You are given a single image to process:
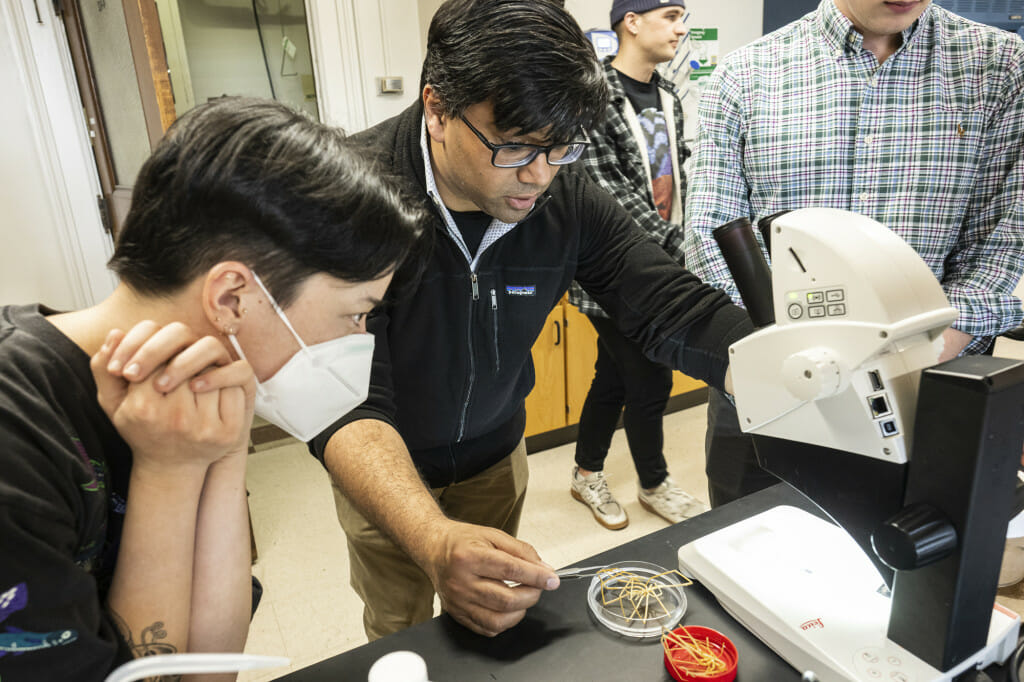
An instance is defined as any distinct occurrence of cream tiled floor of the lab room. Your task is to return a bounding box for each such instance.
[239,341,1024,682]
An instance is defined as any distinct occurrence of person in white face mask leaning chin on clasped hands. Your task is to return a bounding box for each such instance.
[0,98,422,681]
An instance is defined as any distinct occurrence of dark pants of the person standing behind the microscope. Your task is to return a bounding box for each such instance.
[705,388,779,507]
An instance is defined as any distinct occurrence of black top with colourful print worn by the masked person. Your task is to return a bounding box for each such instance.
[0,305,132,682]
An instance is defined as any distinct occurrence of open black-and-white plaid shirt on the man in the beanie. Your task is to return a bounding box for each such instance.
[569,56,690,317]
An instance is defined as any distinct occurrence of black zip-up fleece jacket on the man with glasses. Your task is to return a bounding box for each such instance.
[310,103,754,487]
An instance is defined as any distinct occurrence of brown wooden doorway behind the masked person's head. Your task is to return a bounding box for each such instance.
[59,0,318,236]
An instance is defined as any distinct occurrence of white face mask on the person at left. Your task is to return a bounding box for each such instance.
[227,272,374,442]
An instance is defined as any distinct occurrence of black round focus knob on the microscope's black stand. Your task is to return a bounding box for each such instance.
[871,503,956,570]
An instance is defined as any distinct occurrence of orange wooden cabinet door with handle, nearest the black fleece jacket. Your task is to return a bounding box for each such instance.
[526,302,566,436]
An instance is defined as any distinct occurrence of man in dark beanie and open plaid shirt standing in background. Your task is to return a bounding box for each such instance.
[569,0,706,529]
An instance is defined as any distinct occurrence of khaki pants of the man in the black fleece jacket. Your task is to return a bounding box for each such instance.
[333,440,529,641]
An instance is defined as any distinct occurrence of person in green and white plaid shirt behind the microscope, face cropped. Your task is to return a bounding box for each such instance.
[685,0,1024,506]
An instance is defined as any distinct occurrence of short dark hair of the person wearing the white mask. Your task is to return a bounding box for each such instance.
[110,97,424,305]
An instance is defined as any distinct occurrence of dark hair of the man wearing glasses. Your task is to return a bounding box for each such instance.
[420,0,608,141]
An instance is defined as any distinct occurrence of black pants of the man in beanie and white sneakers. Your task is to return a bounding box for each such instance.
[575,315,672,488]
